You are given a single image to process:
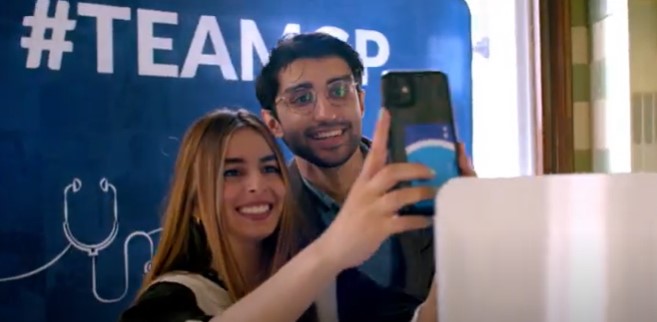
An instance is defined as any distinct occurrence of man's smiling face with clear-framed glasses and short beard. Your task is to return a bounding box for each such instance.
[263,57,364,168]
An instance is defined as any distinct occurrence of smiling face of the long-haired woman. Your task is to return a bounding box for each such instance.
[222,128,286,242]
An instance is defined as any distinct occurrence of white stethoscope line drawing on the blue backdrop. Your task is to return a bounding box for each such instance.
[0,178,162,303]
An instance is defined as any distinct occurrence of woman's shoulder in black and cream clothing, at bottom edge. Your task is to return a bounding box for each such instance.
[120,272,232,322]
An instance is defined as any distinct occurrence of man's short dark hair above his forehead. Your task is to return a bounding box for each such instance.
[256,32,364,112]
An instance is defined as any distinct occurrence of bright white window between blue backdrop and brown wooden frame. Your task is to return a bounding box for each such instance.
[467,0,536,177]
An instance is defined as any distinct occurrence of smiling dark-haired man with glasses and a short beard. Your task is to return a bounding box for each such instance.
[256,33,473,299]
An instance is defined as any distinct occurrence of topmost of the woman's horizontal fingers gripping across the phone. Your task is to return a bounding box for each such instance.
[367,163,435,195]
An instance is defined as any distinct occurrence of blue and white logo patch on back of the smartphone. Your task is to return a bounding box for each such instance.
[405,123,459,212]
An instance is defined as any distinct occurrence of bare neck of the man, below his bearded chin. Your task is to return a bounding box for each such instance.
[296,148,364,204]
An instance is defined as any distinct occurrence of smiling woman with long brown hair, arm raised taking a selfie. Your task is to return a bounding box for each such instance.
[121,110,436,322]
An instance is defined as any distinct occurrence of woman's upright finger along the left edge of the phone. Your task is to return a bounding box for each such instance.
[361,107,390,178]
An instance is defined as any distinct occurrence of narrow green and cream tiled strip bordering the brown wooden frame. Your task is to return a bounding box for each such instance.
[570,0,593,172]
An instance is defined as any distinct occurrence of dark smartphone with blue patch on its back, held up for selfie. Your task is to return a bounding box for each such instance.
[381,70,459,216]
